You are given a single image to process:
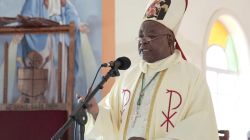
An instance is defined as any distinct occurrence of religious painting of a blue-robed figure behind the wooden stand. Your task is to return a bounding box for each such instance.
[0,0,102,103]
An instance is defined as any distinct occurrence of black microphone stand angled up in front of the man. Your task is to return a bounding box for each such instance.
[51,66,120,140]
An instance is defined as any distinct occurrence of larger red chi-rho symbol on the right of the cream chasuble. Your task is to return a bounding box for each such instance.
[161,89,182,132]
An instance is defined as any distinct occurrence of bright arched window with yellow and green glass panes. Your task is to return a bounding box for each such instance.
[206,15,250,140]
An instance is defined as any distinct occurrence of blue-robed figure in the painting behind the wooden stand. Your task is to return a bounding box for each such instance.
[0,0,100,102]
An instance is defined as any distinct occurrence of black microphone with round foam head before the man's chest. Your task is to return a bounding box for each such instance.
[101,56,131,70]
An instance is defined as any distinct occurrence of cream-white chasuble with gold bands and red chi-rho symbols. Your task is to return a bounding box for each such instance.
[86,50,219,140]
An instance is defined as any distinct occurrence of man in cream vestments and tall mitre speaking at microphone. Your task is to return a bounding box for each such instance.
[83,0,219,140]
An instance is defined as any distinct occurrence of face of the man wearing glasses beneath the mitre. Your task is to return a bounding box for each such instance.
[138,20,175,63]
